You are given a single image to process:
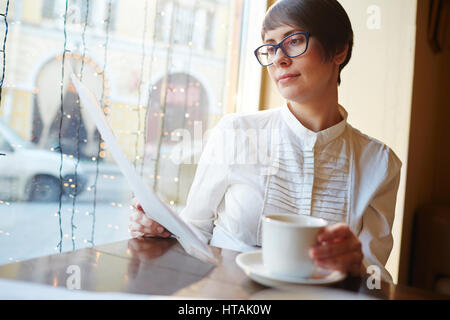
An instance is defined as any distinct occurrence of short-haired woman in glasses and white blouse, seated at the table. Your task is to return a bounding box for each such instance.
[130,0,401,281]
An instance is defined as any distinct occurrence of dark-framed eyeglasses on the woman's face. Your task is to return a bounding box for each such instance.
[255,32,310,67]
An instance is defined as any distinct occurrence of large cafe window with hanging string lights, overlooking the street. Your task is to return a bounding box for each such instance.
[0,0,266,264]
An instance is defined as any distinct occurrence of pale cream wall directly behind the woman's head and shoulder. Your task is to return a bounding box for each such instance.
[261,0,416,281]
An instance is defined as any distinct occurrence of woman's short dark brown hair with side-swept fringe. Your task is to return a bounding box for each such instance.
[261,0,353,84]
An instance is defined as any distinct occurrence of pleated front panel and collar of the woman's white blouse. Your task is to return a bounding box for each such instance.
[264,106,351,222]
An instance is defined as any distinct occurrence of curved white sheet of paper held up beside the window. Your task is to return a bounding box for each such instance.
[71,72,217,264]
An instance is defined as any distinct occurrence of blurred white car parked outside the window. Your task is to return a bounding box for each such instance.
[0,121,87,202]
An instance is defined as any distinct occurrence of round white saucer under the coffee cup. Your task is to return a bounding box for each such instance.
[236,250,346,287]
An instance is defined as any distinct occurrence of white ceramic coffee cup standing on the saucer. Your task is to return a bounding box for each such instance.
[262,214,327,278]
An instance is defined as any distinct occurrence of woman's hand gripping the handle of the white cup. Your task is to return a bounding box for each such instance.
[309,223,363,276]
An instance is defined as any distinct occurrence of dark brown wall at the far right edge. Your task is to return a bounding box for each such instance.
[399,1,450,284]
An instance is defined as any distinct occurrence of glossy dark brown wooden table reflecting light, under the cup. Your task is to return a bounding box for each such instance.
[0,238,450,300]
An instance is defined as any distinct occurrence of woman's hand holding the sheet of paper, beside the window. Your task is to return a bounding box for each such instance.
[128,198,171,238]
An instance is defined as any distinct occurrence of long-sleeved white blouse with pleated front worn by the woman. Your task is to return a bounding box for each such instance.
[180,104,401,281]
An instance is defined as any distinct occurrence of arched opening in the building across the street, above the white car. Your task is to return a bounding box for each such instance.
[32,54,107,159]
